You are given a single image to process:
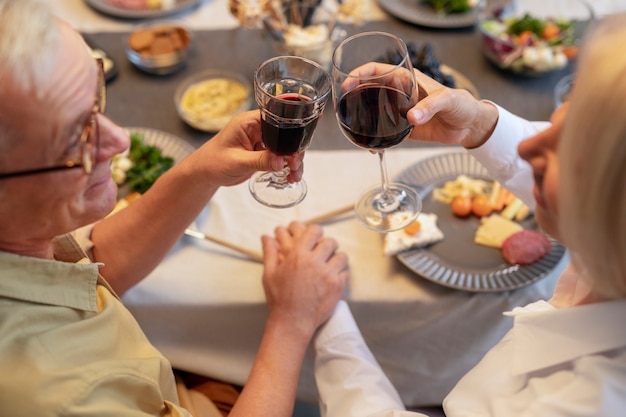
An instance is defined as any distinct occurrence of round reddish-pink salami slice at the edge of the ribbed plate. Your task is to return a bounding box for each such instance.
[502,229,552,265]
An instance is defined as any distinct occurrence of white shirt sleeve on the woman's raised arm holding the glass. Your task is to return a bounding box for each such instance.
[468,103,550,208]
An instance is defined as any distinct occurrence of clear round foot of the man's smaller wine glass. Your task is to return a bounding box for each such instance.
[248,172,307,208]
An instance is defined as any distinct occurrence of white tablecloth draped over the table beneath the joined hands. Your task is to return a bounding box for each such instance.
[124,148,563,405]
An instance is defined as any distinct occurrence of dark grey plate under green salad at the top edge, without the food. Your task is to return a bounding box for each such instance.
[378,0,476,29]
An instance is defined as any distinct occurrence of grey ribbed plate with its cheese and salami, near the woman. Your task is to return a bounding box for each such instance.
[385,151,565,292]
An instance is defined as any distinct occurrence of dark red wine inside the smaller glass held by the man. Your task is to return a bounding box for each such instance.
[261,93,318,155]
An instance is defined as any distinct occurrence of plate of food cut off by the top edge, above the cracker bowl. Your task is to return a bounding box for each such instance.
[84,0,200,19]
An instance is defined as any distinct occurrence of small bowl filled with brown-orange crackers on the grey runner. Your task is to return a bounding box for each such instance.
[126,22,191,75]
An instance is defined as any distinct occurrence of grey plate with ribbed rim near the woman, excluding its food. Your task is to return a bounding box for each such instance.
[396,151,565,292]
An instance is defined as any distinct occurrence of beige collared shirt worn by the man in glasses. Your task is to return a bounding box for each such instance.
[0,235,190,417]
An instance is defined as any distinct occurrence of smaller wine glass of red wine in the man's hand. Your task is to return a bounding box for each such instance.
[248,56,331,208]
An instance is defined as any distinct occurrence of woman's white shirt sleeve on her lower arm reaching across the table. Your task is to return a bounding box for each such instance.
[313,300,422,417]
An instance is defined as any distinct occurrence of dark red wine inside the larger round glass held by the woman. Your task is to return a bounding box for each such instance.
[337,84,413,149]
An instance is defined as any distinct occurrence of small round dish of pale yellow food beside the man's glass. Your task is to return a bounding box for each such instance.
[174,70,252,132]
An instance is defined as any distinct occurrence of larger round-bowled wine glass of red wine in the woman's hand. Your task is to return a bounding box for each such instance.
[332,32,422,232]
